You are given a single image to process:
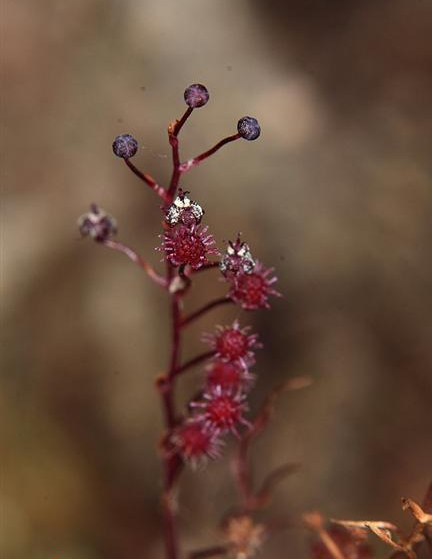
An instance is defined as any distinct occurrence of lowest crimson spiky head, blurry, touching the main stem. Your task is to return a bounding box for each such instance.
[170,419,222,467]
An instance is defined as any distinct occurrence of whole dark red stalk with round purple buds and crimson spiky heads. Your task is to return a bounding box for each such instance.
[78,84,286,559]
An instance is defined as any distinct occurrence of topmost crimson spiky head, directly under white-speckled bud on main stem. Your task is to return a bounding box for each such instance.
[157,224,219,270]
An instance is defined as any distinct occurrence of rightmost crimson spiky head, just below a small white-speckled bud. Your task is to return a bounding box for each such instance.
[229,262,280,310]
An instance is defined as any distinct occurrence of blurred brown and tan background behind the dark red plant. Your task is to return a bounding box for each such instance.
[0,0,432,559]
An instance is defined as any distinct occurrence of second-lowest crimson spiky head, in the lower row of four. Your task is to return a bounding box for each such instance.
[190,386,250,437]
